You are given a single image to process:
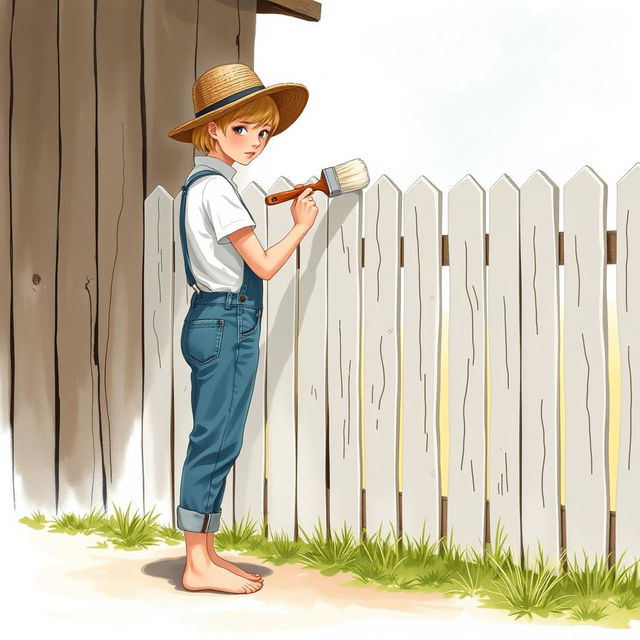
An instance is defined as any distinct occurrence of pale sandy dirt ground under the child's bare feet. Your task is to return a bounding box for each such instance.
[0,522,638,640]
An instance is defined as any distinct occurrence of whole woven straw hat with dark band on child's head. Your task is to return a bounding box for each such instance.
[168,64,309,142]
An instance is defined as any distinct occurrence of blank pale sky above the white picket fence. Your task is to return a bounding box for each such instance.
[238,0,640,231]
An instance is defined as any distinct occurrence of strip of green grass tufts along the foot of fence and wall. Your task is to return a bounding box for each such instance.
[20,505,640,628]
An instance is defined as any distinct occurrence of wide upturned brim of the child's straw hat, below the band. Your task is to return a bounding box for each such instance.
[168,82,309,142]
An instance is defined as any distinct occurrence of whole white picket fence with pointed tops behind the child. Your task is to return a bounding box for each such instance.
[143,164,640,562]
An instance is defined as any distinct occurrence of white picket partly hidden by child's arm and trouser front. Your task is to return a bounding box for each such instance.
[232,182,267,526]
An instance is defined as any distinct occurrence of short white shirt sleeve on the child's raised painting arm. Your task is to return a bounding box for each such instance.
[202,176,256,244]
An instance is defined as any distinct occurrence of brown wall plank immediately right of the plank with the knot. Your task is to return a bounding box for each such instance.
[57,0,104,512]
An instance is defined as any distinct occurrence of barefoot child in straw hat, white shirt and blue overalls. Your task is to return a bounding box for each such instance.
[169,64,318,593]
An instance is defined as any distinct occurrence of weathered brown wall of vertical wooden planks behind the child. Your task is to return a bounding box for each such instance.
[0,0,256,514]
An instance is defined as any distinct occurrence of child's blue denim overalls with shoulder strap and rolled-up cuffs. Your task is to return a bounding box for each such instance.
[176,169,263,533]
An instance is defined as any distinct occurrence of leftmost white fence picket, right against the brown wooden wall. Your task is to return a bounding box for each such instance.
[142,187,173,522]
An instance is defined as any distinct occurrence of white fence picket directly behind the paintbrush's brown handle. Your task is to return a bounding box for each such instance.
[263,178,298,538]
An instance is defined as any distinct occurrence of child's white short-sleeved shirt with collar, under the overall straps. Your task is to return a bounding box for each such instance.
[184,156,256,292]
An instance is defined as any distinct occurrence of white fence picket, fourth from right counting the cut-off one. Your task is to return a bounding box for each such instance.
[487,175,522,562]
